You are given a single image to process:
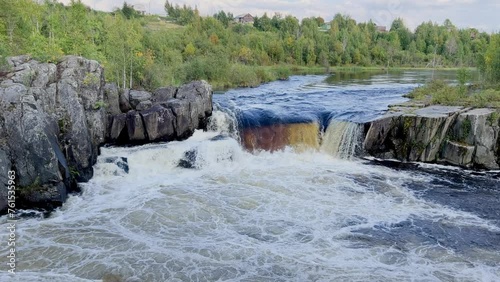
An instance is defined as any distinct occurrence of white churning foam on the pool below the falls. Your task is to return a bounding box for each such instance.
[0,122,500,281]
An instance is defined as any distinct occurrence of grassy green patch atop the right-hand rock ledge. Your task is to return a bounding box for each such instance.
[405,80,500,109]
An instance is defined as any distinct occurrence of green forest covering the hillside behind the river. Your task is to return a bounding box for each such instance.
[0,0,500,89]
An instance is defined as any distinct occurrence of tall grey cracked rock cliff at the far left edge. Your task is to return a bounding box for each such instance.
[0,56,106,210]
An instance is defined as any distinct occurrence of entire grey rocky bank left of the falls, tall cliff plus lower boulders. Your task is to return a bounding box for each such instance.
[0,56,212,214]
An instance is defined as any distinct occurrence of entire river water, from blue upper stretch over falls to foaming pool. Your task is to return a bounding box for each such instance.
[0,73,500,282]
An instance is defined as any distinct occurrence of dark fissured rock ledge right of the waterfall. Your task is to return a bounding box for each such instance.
[364,106,500,169]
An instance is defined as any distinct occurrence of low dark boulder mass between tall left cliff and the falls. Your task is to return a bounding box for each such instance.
[107,81,213,144]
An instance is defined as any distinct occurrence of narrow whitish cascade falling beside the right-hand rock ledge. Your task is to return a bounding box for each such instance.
[320,120,363,159]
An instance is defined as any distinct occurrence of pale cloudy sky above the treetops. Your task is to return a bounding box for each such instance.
[60,0,500,32]
